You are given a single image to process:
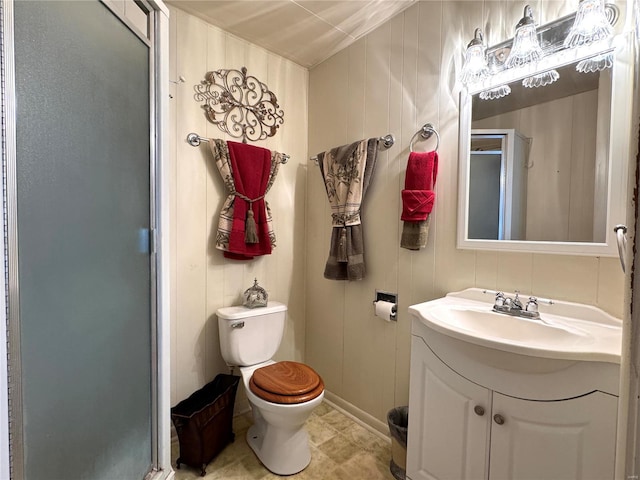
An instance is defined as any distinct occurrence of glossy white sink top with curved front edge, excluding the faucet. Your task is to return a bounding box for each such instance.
[409,288,622,364]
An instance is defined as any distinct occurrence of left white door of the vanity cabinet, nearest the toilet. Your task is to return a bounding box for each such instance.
[407,336,491,480]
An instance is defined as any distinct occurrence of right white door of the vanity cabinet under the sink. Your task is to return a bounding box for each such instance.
[489,392,618,480]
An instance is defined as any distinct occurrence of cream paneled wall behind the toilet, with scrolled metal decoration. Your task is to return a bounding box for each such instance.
[169,7,308,405]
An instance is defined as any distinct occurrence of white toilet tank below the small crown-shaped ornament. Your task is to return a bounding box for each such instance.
[216,302,287,367]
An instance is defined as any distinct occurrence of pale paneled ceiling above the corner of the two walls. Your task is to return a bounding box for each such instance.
[167,0,414,68]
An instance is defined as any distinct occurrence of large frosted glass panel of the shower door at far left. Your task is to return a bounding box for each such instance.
[15,1,152,480]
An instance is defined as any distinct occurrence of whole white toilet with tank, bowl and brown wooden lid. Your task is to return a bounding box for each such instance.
[216,301,324,475]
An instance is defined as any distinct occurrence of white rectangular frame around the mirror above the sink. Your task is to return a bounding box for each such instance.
[457,32,634,257]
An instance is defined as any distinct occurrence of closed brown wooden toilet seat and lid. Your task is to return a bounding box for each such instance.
[249,361,324,404]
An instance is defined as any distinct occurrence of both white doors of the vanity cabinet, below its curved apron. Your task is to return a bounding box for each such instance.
[407,334,618,480]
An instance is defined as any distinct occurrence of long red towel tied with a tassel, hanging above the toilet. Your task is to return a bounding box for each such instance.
[224,142,271,260]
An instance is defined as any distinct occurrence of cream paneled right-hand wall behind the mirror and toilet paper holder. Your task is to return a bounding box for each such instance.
[305,0,624,429]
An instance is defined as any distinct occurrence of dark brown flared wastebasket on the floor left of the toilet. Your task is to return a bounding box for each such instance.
[171,374,240,477]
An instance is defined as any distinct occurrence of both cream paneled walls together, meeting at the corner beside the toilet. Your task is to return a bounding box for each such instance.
[170,0,624,436]
